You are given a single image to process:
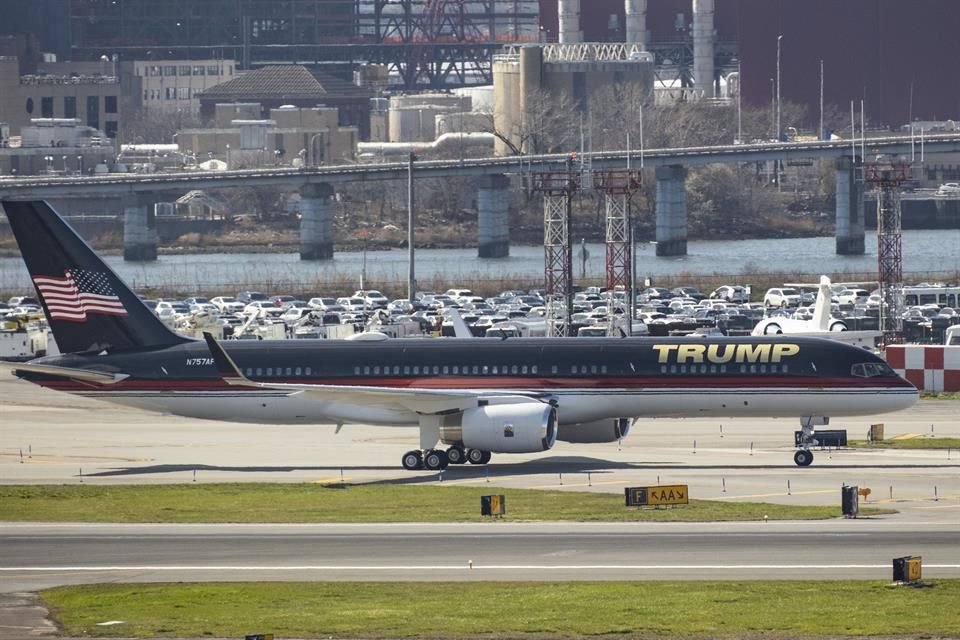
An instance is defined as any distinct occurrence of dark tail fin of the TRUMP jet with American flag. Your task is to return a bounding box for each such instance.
[0,200,189,353]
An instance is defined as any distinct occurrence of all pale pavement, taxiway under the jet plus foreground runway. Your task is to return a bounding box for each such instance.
[0,372,960,590]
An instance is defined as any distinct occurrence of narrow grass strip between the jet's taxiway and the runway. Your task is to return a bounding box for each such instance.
[0,483,895,523]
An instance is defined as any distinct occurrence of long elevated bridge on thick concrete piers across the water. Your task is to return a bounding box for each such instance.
[0,134,960,260]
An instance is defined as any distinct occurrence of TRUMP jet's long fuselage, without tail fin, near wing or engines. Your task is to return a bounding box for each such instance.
[17,336,917,425]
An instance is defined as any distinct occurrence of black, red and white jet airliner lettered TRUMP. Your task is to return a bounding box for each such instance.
[2,201,918,470]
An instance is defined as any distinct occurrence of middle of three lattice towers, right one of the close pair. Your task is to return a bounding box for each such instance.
[593,169,643,335]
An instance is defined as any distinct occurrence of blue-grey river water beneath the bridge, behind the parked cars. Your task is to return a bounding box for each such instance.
[0,229,960,294]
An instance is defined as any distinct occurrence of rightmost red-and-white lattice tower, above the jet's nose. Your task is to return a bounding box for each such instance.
[864,156,911,345]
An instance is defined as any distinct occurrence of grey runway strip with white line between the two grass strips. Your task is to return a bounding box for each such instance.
[0,520,960,591]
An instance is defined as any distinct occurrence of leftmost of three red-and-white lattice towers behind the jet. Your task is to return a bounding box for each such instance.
[533,156,580,338]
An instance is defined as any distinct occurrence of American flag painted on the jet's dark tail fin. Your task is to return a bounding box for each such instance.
[33,269,127,322]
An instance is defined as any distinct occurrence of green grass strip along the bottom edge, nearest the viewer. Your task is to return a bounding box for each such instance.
[42,580,960,639]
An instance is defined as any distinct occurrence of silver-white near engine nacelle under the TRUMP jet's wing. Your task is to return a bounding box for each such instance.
[440,402,557,453]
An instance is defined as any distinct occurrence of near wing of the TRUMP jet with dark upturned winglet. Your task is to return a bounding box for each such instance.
[203,332,541,413]
